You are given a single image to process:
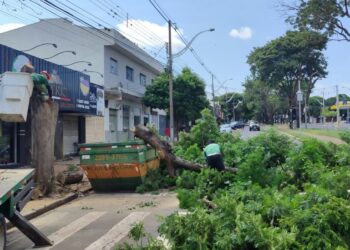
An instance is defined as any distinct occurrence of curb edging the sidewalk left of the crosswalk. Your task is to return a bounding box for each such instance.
[6,188,92,229]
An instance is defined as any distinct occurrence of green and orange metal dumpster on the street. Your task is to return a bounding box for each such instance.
[79,141,159,192]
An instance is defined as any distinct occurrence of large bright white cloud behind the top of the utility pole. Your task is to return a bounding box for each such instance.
[117,19,184,52]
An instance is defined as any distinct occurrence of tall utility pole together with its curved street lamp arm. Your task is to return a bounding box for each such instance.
[168,20,215,141]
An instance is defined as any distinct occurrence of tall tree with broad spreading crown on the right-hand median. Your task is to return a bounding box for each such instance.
[248,31,327,107]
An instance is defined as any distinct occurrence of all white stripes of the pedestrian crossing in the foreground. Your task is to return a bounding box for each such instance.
[6,211,150,250]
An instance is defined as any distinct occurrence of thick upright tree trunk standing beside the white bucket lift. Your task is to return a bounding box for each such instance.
[31,95,58,195]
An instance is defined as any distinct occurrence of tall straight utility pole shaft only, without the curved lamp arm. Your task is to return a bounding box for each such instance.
[168,20,174,142]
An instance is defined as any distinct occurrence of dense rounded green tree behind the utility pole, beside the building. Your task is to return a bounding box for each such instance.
[143,68,209,131]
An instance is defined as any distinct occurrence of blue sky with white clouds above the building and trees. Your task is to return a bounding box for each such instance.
[0,0,350,96]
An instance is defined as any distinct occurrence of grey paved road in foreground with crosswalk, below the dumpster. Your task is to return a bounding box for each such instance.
[6,193,178,250]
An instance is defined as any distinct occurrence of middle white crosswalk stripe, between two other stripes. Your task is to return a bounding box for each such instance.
[30,212,106,250]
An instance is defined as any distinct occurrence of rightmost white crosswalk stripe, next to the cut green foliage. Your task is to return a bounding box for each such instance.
[85,212,150,250]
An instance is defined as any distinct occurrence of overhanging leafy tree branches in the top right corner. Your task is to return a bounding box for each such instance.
[282,0,350,42]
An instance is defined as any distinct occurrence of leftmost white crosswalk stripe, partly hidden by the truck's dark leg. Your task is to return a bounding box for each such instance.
[6,212,68,246]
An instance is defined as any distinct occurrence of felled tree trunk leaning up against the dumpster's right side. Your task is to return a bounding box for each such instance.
[134,125,237,176]
